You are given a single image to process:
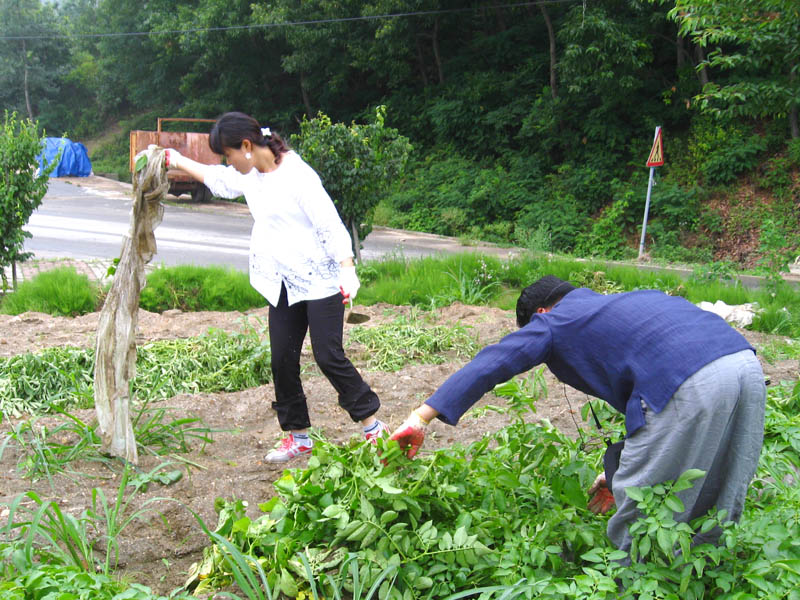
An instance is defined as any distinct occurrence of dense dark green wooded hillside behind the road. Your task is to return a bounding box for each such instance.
[0,0,800,272]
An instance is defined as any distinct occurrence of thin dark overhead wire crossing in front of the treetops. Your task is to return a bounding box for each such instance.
[0,0,586,40]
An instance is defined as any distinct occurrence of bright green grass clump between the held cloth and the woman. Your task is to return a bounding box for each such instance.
[139,265,267,312]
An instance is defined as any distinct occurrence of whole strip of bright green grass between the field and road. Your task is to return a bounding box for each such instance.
[0,252,800,337]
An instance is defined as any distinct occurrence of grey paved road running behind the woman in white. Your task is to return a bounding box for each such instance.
[4,176,514,280]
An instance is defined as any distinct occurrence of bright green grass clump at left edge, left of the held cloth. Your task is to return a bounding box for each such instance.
[0,267,100,317]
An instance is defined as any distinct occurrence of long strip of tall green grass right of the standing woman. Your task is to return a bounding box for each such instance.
[358,253,800,337]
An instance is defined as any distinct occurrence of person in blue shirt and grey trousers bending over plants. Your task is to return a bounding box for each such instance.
[391,275,766,551]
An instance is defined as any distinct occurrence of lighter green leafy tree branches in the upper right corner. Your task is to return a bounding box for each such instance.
[669,0,800,139]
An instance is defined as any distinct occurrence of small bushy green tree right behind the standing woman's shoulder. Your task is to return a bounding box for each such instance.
[292,106,412,262]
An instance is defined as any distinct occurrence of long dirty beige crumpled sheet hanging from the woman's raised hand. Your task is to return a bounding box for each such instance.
[94,146,169,464]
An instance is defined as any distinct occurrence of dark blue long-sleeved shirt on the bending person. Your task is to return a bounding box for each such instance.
[426,288,755,435]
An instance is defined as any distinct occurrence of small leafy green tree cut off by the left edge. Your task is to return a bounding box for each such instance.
[0,111,52,289]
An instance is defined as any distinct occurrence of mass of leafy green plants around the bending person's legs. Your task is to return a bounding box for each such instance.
[190,384,800,600]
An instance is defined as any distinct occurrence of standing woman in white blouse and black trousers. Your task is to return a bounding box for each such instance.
[166,112,386,462]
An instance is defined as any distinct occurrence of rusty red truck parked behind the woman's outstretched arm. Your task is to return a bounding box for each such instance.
[129,117,222,202]
